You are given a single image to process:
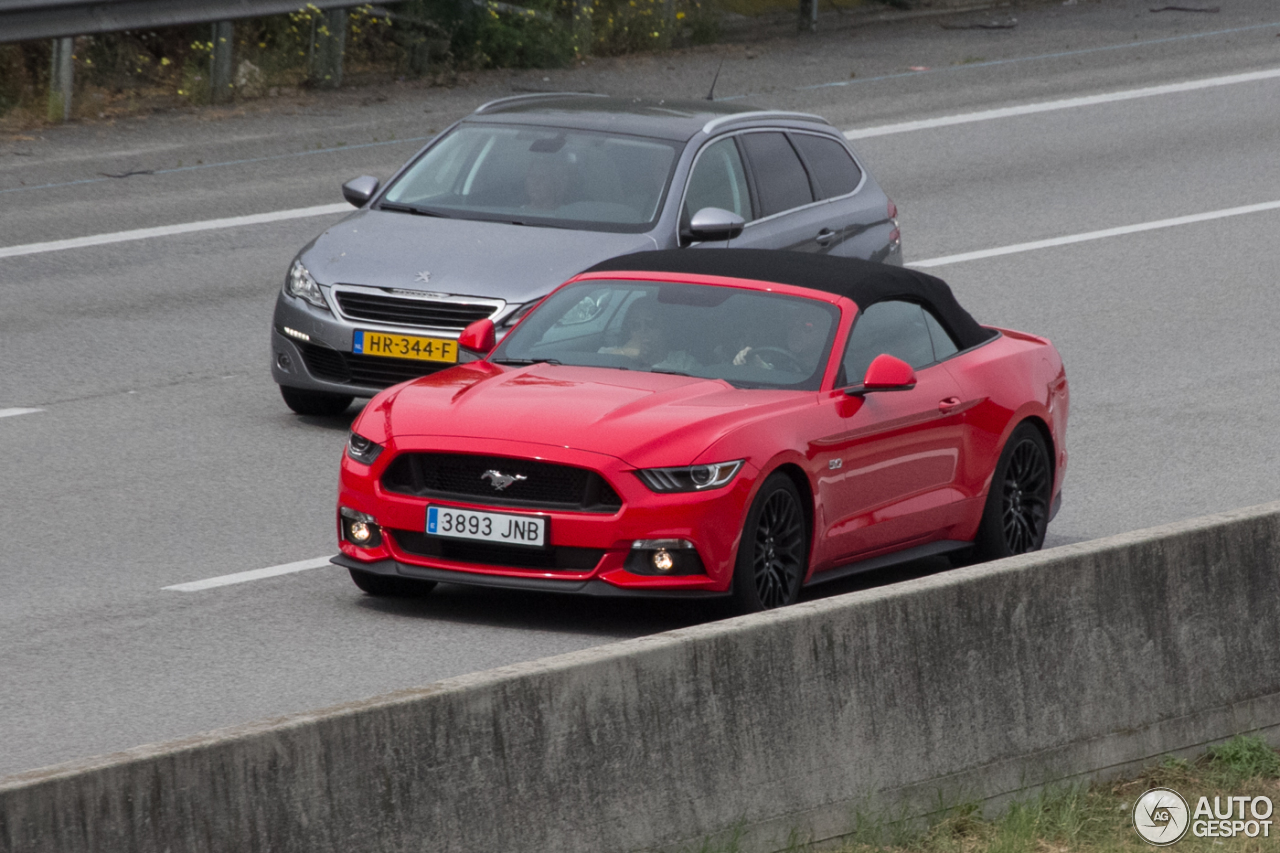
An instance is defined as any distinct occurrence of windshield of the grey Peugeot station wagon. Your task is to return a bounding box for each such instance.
[383,124,677,232]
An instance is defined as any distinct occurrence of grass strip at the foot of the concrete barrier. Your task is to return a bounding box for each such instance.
[699,736,1280,853]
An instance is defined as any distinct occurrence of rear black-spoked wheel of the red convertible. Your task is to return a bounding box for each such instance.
[973,421,1053,561]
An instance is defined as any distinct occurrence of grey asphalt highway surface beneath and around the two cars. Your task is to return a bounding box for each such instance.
[0,0,1280,775]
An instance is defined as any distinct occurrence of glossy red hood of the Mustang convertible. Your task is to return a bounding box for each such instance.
[371,362,812,467]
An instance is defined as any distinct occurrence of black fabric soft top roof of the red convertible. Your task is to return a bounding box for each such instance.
[585,248,995,350]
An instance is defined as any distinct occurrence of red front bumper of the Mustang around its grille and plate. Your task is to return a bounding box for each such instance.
[334,437,756,597]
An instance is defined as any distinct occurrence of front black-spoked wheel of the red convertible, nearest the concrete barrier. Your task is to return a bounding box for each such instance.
[733,474,809,613]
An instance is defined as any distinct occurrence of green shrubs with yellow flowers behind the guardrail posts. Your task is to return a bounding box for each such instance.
[0,0,906,127]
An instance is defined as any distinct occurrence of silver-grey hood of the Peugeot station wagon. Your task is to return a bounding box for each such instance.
[302,210,657,302]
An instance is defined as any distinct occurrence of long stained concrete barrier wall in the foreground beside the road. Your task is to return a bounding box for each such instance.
[0,503,1280,853]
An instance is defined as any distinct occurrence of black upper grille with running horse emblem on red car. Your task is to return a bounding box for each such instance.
[383,453,622,512]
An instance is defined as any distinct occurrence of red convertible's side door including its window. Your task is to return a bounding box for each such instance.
[812,301,965,566]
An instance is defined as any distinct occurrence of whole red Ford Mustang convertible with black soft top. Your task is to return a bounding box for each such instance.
[334,250,1068,612]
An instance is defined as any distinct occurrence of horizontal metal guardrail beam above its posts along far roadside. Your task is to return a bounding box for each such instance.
[0,0,358,44]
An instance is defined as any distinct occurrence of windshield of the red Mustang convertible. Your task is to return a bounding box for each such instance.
[490,280,840,391]
